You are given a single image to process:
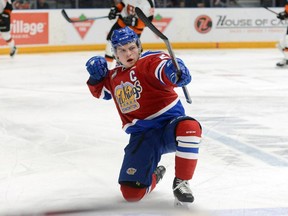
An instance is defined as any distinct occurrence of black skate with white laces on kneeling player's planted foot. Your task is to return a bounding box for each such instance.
[173,177,194,206]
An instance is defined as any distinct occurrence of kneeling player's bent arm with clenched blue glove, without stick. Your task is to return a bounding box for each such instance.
[86,56,112,100]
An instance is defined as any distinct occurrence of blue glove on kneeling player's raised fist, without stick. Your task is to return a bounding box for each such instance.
[86,56,108,82]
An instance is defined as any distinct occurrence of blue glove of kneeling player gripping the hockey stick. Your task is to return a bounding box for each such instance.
[164,58,191,87]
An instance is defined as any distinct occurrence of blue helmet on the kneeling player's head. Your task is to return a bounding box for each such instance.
[111,26,142,52]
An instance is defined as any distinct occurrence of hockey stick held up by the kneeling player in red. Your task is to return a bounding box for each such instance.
[135,7,192,104]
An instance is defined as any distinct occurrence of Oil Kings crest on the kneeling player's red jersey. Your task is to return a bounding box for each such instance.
[114,81,142,113]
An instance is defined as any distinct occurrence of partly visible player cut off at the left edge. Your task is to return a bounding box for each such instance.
[0,0,17,57]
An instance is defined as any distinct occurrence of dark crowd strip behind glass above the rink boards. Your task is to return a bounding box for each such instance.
[12,0,286,9]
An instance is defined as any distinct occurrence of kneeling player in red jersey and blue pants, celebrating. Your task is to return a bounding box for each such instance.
[86,27,202,204]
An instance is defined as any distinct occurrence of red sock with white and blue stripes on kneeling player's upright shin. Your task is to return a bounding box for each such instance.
[175,120,202,180]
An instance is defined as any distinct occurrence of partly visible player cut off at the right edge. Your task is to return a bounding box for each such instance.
[276,0,288,67]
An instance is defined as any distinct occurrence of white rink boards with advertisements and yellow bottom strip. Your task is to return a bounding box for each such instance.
[0,8,287,54]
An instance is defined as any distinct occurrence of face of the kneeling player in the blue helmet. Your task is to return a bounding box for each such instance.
[116,42,140,68]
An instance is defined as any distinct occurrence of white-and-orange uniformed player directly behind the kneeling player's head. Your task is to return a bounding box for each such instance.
[105,0,155,66]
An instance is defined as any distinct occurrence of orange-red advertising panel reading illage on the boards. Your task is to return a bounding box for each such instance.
[0,12,49,45]
